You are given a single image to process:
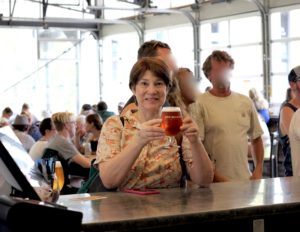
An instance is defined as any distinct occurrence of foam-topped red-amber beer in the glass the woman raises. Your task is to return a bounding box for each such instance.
[161,107,182,136]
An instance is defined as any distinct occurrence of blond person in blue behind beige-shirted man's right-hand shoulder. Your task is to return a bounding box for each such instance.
[249,88,270,124]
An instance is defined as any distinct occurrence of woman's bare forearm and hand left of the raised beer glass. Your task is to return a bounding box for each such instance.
[99,119,164,188]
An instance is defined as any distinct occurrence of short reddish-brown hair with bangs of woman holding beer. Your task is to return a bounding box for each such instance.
[129,57,172,89]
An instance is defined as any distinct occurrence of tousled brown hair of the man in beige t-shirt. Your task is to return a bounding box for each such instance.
[202,50,234,78]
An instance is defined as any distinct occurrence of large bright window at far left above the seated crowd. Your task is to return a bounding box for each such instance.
[0,28,99,118]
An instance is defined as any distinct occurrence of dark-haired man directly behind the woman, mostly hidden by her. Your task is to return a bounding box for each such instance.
[121,40,179,115]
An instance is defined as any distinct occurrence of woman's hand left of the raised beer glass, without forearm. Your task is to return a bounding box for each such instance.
[136,119,165,146]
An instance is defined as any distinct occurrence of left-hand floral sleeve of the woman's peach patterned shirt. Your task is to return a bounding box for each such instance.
[95,115,123,164]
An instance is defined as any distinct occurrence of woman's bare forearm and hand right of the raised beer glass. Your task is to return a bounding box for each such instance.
[181,117,214,185]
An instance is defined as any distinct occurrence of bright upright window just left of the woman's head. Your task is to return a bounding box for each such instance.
[101,33,139,113]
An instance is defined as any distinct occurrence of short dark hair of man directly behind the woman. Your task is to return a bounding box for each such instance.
[137,40,171,60]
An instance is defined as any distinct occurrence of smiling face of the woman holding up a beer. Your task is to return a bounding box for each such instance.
[132,70,167,111]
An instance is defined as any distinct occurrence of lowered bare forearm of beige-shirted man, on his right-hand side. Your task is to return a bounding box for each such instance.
[250,137,264,180]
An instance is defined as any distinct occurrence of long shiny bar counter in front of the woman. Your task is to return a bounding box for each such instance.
[59,177,300,232]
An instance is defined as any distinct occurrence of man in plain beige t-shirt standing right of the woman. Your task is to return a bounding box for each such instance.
[193,50,264,182]
